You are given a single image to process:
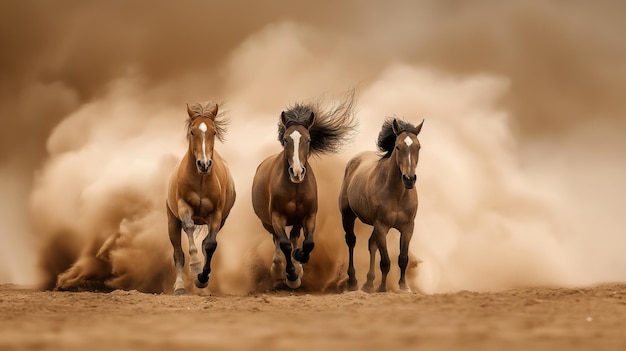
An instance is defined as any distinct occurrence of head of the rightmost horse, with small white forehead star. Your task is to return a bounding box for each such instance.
[392,118,424,189]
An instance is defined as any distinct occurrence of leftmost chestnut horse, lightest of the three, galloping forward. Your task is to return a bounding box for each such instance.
[167,104,235,295]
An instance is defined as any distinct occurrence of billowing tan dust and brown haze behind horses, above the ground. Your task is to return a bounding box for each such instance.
[0,1,626,294]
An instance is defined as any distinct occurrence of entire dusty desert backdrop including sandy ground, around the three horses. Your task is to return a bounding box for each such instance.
[0,0,626,350]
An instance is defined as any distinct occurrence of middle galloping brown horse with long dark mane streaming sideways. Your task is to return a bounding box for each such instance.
[252,91,356,289]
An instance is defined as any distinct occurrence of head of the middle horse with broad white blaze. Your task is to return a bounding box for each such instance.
[280,111,315,184]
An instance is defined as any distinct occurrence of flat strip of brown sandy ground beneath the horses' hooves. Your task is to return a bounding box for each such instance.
[0,284,626,350]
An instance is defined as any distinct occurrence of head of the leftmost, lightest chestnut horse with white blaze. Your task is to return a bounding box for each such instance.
[187,104,219,174]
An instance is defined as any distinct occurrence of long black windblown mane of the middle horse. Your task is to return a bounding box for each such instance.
[278,89,357,155]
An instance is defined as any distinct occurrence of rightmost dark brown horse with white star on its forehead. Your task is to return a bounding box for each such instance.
[339,118,424,292]
